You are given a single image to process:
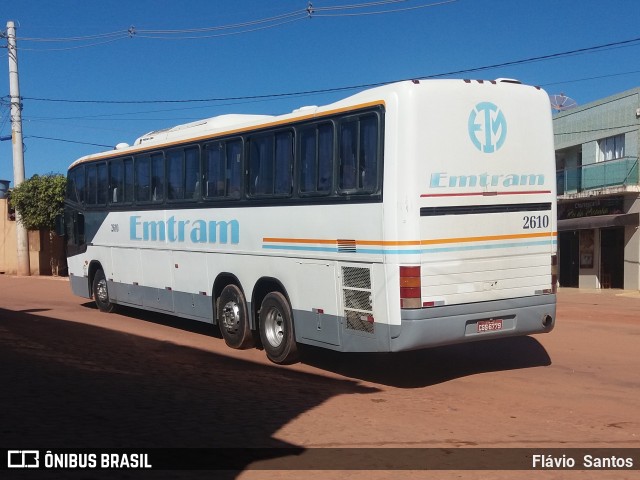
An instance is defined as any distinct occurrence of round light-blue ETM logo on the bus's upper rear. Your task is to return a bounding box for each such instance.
[469,102,507,153]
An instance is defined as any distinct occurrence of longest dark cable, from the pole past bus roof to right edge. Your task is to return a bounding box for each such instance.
[17,37,640,105]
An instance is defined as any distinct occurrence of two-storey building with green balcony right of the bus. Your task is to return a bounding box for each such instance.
[553,88,640,291]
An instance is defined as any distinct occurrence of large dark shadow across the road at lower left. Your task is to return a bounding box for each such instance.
[0,309,376,478]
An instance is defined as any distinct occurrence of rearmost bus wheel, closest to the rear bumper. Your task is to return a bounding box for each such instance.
[260,292,298,364]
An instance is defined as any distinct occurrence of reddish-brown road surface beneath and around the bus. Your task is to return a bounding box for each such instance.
[0,275,640,479]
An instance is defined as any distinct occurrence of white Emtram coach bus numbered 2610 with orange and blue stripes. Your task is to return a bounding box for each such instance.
[65,79,557,363]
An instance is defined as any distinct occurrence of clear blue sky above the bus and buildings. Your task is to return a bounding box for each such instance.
[0,0,640,181]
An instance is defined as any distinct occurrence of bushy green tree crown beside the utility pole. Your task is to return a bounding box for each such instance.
[11,173,67,230]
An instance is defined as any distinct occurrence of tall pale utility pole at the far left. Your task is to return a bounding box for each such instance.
[6,21,31,276]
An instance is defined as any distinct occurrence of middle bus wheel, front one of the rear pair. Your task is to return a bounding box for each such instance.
[218,285,253,349]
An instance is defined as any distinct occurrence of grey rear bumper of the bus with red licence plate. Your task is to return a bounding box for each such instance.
[390,295,556,352]
